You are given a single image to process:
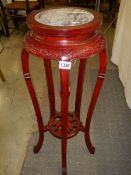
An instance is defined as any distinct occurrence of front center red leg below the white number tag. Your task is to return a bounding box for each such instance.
[60,69,70,175]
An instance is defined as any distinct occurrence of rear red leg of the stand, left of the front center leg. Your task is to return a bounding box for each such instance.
[44,60,55,117]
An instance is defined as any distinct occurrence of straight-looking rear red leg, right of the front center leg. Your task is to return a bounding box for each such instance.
[75,59,87,117]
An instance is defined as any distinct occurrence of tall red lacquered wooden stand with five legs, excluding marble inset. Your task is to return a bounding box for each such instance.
[22,7,107,175]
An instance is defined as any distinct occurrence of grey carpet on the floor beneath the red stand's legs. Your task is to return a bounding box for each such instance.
[21,66,131,175]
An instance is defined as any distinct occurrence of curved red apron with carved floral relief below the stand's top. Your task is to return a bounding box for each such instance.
[24,32,105,61]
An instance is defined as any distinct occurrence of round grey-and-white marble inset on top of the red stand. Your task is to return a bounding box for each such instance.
[35,8,94,26]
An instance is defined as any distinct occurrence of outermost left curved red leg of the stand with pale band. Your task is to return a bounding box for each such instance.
[21,49,44,153]
